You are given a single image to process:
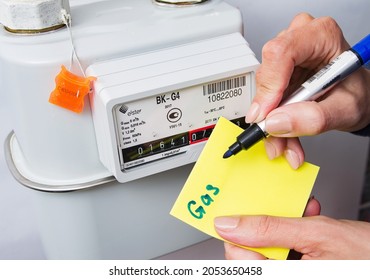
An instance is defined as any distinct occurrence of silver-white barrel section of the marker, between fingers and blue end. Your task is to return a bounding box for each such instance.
[280,50,362,106]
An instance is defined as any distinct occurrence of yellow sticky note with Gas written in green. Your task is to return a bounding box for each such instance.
[170,118,319,259]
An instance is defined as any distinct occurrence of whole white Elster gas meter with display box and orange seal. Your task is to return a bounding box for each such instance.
[0,0,258,260]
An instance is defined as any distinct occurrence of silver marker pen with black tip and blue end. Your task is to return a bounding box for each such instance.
[223,34,370,158]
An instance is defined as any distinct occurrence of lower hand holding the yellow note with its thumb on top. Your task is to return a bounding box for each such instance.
[215,200,370,260]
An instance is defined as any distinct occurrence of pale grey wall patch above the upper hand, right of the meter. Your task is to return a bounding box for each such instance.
[225,0,370,57]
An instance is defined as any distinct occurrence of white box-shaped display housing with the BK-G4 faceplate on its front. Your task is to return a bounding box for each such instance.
[88,33,258,182]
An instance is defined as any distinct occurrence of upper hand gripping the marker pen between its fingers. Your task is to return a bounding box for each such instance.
[246,14,370,169]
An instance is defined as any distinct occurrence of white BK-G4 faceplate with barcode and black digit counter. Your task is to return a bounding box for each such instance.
[113,73,252,170]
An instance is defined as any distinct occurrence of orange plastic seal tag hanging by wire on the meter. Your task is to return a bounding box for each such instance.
[49,65,96,113]
